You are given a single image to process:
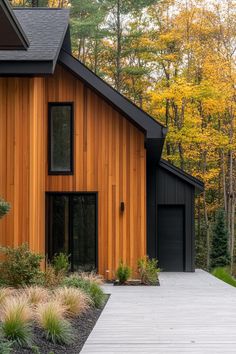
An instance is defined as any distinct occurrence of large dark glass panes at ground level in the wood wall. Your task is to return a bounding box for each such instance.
[48,193,97,271]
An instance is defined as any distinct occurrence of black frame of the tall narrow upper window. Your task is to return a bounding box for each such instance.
[48,102,74,176]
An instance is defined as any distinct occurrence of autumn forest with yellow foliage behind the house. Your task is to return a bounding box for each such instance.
[11,0,236,269]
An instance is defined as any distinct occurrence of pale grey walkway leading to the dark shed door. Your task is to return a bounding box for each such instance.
[81,270,236,354]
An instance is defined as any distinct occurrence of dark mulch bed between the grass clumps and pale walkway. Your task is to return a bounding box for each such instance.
[12,298,109,354]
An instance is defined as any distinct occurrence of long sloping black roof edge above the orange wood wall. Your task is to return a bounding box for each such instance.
[58,49,167,141]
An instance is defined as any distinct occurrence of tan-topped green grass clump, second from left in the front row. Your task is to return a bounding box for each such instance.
[36,301,72,344]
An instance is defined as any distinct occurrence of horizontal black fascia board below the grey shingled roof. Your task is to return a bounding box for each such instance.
[0,60,55,76]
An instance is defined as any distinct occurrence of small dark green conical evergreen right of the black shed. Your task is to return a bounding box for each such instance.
[211,209,230,268]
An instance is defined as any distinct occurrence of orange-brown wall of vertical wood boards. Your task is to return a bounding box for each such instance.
[0,66,146,278]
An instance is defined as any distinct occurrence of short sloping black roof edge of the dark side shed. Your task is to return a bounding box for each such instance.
[159,159,204,192]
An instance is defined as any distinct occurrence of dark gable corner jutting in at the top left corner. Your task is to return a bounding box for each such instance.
[0,0,29,50]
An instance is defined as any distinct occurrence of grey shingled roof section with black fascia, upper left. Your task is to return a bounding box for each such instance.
[0,7,69,74]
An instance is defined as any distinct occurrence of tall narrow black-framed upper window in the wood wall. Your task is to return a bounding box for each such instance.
[48,103,73,174]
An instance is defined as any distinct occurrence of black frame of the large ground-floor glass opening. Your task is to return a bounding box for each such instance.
[45,191,98,271]
